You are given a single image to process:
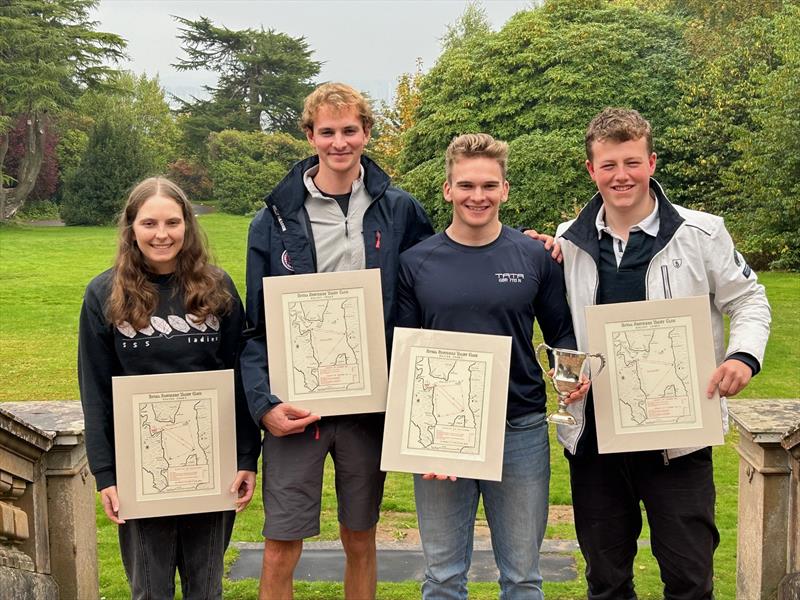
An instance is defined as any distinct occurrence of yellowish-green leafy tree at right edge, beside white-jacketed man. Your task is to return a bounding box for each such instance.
[663,0,800,269]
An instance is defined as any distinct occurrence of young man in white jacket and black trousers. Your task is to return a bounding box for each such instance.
[557,108,770,600]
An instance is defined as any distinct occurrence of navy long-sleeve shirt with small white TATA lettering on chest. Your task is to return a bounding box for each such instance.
[397,226,576,419]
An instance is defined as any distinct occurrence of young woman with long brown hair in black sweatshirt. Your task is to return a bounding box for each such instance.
[78,177,260,600]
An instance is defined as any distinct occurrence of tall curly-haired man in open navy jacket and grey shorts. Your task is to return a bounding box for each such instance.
[242,83,433,600]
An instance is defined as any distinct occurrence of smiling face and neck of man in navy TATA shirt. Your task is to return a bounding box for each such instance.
[444,157,508,243]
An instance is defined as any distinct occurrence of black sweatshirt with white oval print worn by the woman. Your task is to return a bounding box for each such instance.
[78,269,261,490]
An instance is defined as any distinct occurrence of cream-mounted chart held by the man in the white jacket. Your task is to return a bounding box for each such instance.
[586,296,724,454]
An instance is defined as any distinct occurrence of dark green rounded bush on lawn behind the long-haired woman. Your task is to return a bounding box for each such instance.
[61,119,155,225]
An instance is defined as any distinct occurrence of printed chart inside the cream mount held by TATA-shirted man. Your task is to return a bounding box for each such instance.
[400,347,492,460]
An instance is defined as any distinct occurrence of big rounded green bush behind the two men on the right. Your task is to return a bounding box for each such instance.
[400,0,687,231]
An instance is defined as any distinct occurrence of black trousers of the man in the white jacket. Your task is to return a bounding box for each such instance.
[568,448,719,600]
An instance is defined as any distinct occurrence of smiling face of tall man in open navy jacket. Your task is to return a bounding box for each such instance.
[306,104,370,181]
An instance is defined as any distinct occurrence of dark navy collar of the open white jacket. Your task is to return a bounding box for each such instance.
[562,178,684,263]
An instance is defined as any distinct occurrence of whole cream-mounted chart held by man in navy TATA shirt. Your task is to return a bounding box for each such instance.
[381,327,511,481]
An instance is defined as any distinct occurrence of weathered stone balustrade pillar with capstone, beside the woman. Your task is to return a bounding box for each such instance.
[3,401,99,600]
